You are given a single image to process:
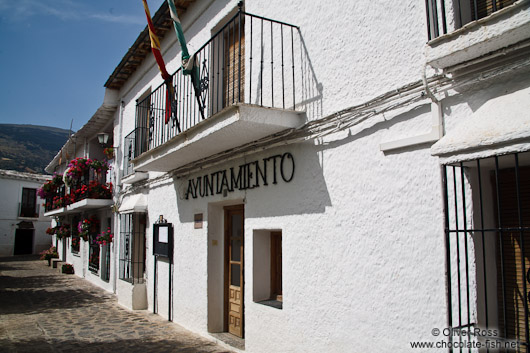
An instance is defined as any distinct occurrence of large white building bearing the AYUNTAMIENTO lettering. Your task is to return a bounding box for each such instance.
[42,0,530,353]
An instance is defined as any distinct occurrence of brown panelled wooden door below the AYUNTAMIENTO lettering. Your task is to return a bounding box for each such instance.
[225,205,244,338]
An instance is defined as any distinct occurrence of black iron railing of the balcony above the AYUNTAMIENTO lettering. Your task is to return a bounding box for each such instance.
[134,11,301,153]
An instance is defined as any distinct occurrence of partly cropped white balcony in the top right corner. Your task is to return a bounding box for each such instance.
[426,0,530,69]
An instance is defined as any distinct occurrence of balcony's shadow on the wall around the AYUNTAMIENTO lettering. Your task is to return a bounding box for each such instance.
[174,142,331,223]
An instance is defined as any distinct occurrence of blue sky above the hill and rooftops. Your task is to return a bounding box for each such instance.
[0,0,164,130]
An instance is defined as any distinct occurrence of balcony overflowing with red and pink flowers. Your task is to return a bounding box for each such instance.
[39,158,113,216]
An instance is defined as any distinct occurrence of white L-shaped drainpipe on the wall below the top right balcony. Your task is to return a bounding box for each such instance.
[379,64,444,152]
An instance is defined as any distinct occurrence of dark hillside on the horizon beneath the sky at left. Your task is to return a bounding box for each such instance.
[0,124,69,173]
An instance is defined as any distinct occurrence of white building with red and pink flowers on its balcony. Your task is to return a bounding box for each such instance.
[45,90,118,291]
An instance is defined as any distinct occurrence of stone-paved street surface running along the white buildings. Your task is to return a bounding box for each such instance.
[0,256,231,353]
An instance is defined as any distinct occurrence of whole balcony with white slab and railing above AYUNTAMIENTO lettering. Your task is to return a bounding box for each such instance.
[124,11,304,173]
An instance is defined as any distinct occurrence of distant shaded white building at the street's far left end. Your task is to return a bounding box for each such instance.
[0,170,52,256]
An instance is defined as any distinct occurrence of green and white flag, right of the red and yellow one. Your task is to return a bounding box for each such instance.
[167,0,204,119]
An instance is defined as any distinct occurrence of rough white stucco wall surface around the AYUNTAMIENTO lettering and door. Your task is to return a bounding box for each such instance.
[108,0,530,353]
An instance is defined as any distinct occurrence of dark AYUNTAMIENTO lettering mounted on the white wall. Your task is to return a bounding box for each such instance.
[186,152,295,200]
